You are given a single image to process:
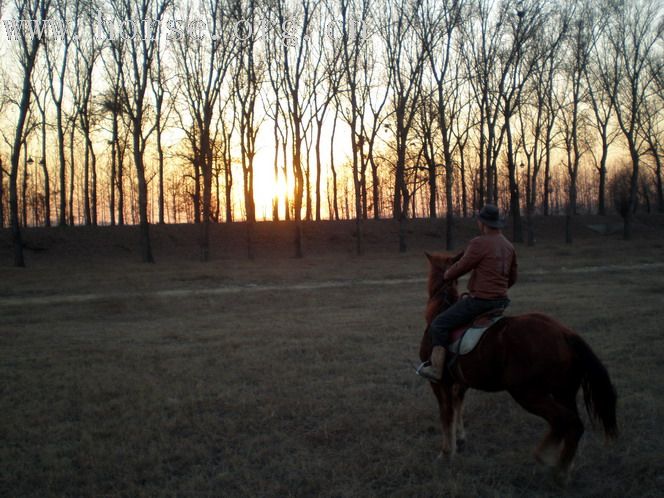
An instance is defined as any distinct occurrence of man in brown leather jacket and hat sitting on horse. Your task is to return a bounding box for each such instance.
[418,204,517,382]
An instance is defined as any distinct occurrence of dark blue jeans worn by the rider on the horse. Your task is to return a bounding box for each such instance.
[429,297,510,347]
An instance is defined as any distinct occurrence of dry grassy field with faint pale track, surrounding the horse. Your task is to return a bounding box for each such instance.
[0,216,664,497]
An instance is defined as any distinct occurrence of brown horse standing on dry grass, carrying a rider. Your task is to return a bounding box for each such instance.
[420,253,618,480]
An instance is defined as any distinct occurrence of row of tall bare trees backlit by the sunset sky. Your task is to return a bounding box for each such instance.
[0,0,664,266]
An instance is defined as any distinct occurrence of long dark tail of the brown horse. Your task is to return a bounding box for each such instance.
[568,334,618,438]
